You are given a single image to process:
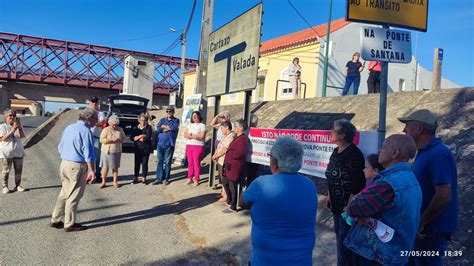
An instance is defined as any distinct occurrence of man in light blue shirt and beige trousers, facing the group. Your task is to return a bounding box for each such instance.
[50,109,98,232]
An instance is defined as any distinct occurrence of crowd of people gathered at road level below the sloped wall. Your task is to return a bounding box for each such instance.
[0,94,458,266]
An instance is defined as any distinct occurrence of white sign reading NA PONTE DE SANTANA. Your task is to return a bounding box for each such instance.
[360,27,411,64]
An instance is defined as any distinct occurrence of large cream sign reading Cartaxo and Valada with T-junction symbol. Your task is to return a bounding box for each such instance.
[206,3,262,96]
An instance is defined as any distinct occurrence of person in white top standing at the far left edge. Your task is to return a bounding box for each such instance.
[0,109,25,194]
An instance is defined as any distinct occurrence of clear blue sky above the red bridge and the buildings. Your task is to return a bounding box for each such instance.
[0,0,474,86]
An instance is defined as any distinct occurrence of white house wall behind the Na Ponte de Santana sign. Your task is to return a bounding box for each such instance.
[317,23,460,96]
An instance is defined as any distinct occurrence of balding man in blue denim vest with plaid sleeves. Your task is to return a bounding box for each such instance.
[344,134,421,266]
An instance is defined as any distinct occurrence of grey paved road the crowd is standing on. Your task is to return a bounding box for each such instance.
[0,111,335,265]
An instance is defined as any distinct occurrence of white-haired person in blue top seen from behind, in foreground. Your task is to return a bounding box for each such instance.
[241,137,318,265]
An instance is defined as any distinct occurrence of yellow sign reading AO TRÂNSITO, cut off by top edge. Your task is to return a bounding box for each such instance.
[346,0,428,32]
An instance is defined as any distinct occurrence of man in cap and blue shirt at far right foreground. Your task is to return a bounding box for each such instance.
[398,109,458,265]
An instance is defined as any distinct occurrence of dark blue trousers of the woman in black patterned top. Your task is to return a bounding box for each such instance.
[332,213,352,266]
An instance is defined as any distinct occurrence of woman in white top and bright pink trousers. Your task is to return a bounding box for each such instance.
[184,111,206,186]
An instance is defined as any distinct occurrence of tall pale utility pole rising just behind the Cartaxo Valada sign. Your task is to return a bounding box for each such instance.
[194,0,217,123]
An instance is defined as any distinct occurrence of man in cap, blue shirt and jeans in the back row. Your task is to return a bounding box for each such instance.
[150,106,179,185]
